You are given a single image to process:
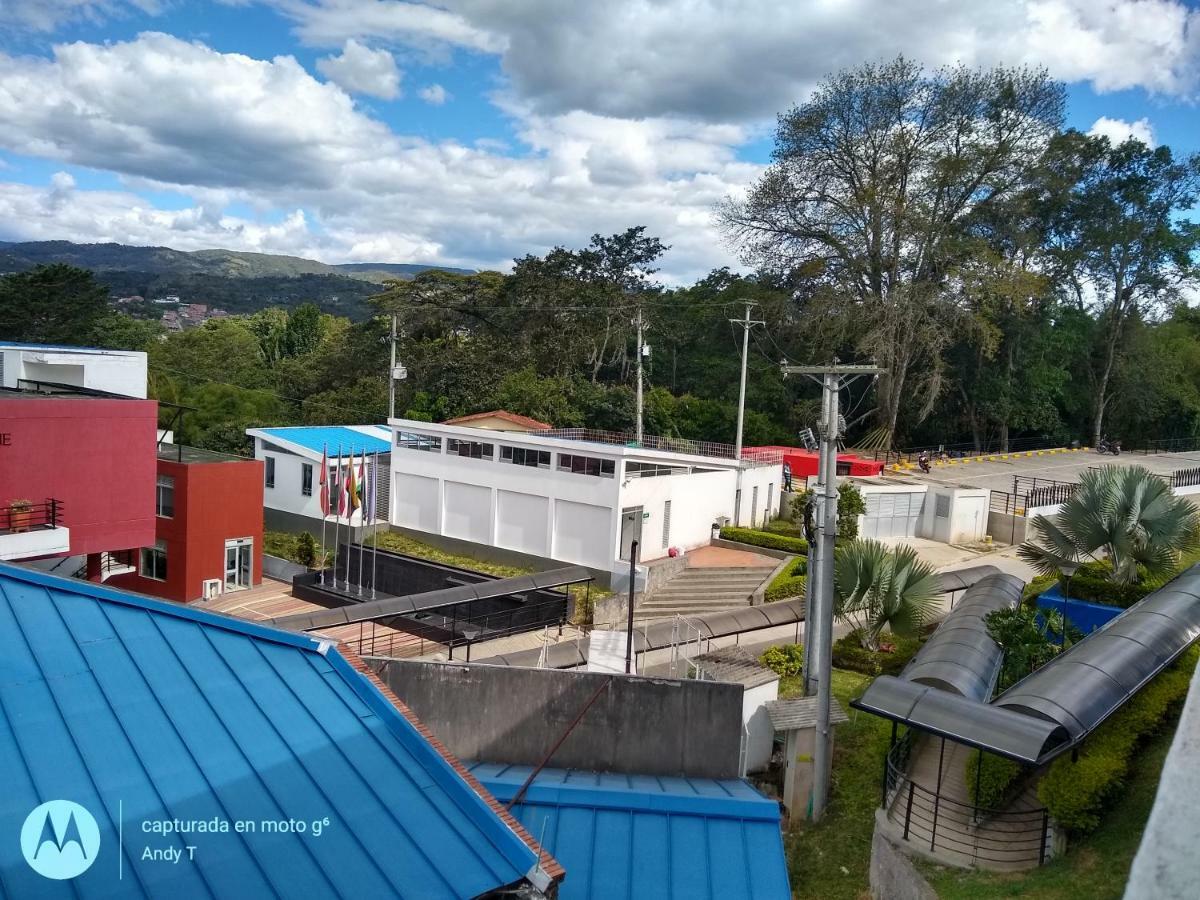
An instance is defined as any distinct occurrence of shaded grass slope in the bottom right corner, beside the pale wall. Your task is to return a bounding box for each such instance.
[922,718,1178,900]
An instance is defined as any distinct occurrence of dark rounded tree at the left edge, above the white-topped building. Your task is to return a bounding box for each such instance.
[0,264,108,344]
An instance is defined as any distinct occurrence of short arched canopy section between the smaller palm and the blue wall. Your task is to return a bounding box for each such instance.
[900,572,1025,702]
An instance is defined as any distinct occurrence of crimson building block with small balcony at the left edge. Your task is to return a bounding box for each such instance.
[0,391,158,568]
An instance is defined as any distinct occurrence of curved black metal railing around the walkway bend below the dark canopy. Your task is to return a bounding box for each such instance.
[883,742,1054,866]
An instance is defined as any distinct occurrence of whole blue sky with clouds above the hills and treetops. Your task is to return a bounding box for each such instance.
[0,0,1200,283]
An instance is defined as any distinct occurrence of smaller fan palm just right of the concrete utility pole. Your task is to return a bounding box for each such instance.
[833,540,941,650]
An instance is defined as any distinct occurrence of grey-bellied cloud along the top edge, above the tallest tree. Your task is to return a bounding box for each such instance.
[264,0,1200,121]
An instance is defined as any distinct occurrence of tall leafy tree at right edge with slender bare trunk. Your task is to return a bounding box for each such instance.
[1054,132,1200,445]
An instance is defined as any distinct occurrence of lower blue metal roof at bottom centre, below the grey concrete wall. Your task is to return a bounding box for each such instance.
[470,763,791,900]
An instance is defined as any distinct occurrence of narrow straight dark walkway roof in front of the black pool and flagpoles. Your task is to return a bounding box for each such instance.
[269,565,595,631]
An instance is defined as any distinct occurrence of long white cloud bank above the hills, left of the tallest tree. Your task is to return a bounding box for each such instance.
[0,34,761,281]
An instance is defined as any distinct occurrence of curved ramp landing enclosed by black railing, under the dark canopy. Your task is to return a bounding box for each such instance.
[887,737,1054,871]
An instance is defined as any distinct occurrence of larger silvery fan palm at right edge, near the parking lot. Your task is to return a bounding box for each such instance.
[1016,466,1200,584]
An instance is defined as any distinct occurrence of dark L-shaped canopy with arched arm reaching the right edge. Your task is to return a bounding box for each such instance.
[851,565,1200,764]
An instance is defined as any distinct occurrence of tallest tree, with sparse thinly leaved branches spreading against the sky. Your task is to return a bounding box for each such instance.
[720,59,1063,446]
